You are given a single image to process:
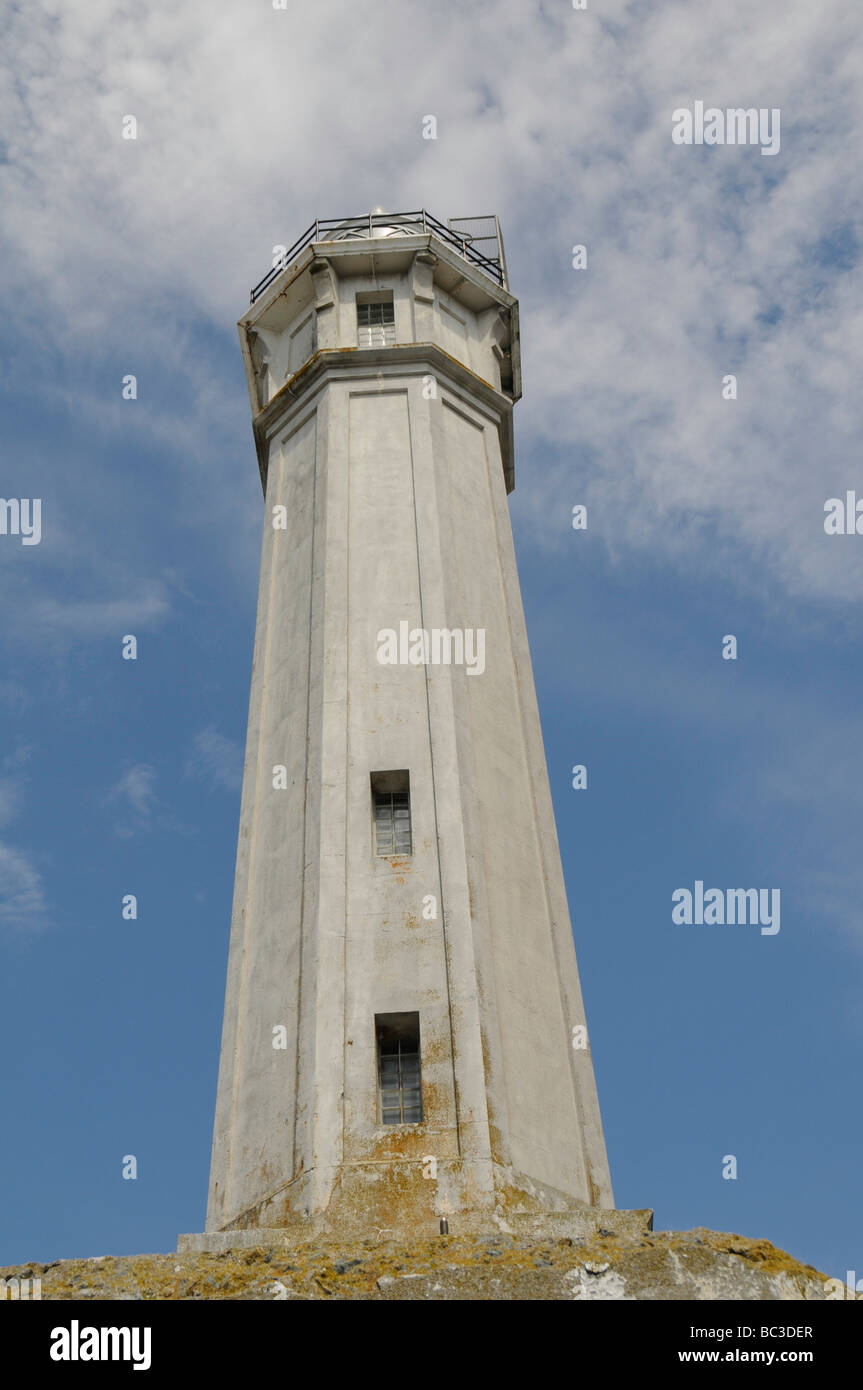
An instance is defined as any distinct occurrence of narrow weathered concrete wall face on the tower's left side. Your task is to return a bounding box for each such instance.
[207,414,321,1229]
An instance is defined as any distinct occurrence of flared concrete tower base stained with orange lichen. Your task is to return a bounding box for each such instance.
[176,1161,653,1252]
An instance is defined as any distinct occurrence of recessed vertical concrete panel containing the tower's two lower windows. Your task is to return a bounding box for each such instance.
[345,391,454,1163]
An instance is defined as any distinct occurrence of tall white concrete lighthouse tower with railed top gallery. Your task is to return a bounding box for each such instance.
[193,211,613,1243]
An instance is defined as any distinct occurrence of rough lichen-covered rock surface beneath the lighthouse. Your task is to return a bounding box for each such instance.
[0,1229,837,1301]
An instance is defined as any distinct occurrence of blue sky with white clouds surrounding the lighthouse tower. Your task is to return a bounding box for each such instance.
[0,0,863,1277]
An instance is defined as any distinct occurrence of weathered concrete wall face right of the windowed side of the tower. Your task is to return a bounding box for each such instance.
[434,392,613,1207]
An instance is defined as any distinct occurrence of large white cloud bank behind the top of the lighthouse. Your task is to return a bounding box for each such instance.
[0,0,863,614]
